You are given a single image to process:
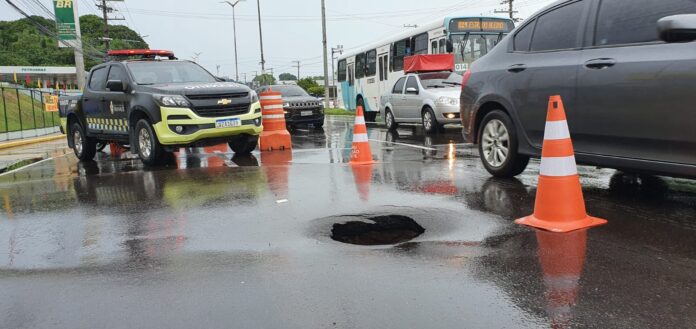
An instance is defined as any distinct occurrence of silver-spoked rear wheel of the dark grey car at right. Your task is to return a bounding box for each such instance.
[478,110,529,177]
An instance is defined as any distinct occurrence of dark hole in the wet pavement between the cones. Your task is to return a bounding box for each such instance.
[331,215,425,246]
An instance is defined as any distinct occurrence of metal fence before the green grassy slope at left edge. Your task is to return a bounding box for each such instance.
[0,87,60,133]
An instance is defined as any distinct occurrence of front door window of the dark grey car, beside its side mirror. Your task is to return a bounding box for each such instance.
[595,0,696,46]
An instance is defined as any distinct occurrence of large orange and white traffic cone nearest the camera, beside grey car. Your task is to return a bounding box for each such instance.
[515,96,607,232]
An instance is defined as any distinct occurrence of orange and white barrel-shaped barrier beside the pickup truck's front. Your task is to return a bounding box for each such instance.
[259,91,292,152]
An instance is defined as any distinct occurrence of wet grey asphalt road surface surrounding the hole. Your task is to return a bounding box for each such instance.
[0,118,696,328]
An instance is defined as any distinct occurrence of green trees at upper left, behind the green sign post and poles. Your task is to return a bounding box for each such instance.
[0,15,149,70]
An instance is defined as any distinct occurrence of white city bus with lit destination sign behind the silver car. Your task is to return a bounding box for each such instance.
[335,17,515,122]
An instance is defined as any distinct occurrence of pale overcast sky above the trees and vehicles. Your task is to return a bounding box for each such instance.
[0,0,556,81]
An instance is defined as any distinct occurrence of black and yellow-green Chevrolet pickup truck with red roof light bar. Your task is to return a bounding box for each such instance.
[61,50,263,165]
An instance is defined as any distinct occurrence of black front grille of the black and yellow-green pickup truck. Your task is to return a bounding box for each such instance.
[186,92,251,118]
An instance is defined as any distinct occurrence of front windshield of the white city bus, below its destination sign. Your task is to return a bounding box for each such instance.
[451,33,504,72]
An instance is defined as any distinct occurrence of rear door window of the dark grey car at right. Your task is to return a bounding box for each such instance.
[531,1,586,51]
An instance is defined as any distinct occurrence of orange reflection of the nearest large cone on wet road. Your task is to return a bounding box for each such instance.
[537,230,587,328]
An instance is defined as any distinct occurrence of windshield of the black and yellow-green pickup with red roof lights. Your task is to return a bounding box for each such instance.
[127,61,217,85]
